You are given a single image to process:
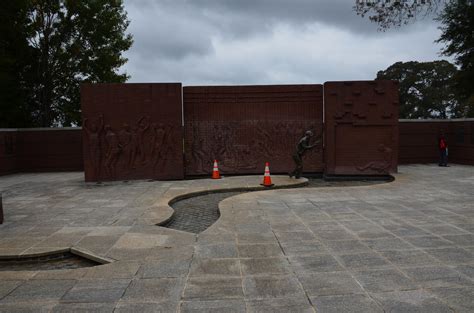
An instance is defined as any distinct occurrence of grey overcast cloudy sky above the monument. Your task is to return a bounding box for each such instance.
[123,0,442,86]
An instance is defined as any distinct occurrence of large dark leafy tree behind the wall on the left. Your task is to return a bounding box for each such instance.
[0,0,132,127]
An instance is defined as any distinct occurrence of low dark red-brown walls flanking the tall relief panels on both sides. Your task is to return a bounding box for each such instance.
[0,119,474,175]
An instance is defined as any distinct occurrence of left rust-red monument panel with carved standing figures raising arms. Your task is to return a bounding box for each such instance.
[81,83,184,181]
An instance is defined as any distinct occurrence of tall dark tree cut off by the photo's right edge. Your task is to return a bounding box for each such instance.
[437,0,474,117]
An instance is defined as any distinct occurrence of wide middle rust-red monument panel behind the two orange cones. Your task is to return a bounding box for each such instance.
[183,85,324,175]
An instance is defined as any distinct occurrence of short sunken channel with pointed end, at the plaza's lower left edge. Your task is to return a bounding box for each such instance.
[0,249,110,271]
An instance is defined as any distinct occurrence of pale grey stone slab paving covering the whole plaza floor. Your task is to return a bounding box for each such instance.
[0,165,474,313]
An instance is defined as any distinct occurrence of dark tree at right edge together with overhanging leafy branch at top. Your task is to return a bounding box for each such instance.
[354,0,474,117]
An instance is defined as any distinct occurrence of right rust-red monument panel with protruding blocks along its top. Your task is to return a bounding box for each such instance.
[324,81,398,175]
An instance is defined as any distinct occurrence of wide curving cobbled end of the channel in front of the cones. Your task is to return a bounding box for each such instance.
[161,191,243,234]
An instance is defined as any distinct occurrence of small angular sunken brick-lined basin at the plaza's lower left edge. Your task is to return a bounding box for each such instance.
[0,252,102,271]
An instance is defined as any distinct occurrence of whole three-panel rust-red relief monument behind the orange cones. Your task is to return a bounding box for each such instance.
[83,82,398,181]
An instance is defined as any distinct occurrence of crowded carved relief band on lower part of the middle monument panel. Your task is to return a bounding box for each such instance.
[186,121,321,175]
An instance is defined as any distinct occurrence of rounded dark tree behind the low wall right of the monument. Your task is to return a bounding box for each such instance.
[376,61,463,119]
